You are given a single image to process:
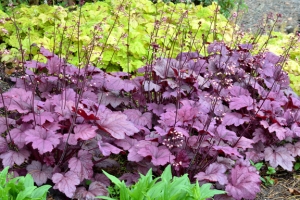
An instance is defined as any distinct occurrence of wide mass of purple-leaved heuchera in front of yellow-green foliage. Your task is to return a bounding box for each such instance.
[0,36,300,199]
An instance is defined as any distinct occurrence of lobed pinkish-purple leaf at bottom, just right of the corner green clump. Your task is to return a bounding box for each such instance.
[52,171,80,198]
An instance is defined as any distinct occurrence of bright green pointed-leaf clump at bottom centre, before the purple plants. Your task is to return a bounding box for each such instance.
[98,165,225,200]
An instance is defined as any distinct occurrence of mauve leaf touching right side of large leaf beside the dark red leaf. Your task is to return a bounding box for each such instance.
[123,109,152,129]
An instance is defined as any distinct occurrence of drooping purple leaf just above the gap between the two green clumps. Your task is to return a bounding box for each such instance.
[68,150,94,181]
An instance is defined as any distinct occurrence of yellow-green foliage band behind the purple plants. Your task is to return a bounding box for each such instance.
[0,0,300,93]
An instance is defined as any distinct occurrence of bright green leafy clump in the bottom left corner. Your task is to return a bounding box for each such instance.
[0,167,51,200]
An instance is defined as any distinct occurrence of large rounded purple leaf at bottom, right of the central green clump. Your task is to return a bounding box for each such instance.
[225,165,260,200]
